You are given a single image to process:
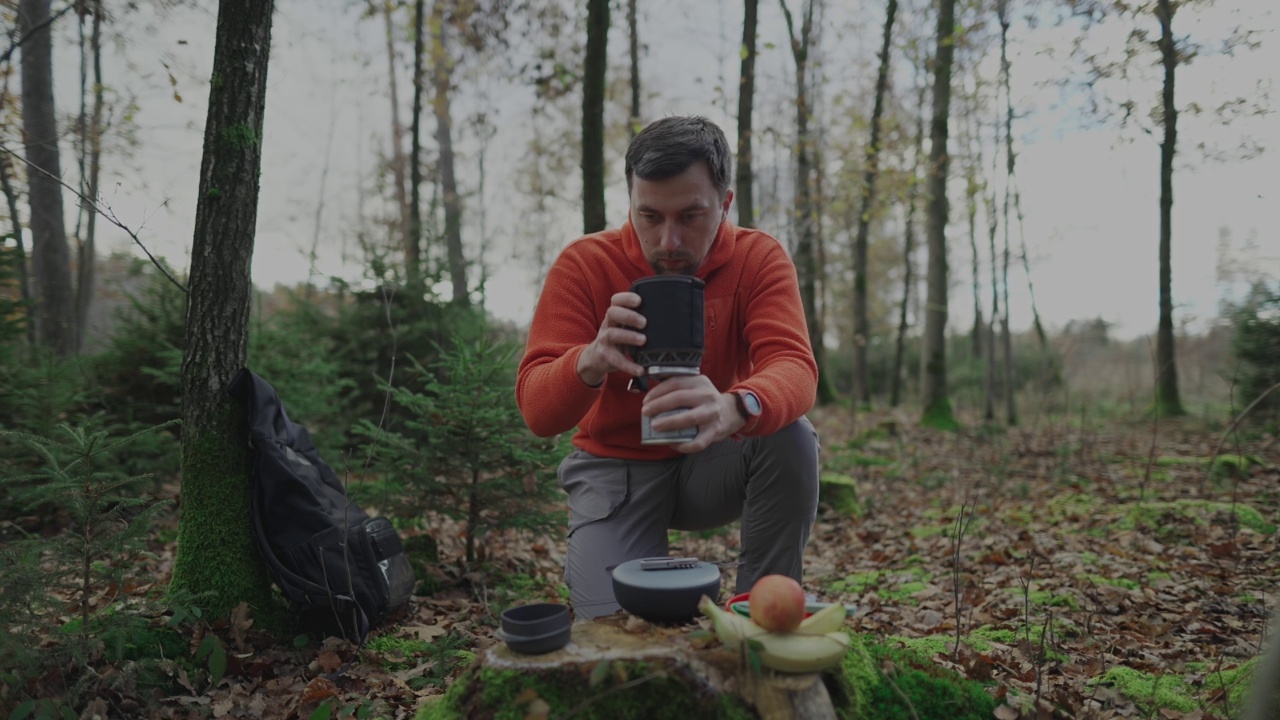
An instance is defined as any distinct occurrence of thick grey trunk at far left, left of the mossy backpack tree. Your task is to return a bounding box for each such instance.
[18,0,77,357]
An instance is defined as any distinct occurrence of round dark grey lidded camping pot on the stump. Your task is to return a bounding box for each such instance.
[613,557,721,624]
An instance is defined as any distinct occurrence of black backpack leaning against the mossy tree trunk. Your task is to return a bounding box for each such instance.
[227,368,415,642]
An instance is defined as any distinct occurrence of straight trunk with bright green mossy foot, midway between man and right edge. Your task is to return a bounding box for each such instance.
[920,0,956,427]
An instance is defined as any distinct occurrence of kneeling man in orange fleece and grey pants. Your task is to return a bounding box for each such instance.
[516,118,818,619]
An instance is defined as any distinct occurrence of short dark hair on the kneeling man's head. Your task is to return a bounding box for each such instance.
[626,117,733,196]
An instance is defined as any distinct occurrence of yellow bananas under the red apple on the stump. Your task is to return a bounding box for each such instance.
[698,596,849,673]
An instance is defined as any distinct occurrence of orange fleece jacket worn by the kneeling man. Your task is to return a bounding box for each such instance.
[516,215,818,460]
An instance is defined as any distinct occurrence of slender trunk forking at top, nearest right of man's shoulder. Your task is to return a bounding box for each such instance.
[780,0,835,405]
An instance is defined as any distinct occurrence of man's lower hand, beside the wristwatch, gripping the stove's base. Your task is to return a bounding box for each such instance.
[640,375,746,454]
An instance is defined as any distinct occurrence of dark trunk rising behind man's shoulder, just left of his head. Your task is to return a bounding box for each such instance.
[582,0,609,233]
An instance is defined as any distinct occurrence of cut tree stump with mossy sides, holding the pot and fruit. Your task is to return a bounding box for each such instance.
[419,614,856,720]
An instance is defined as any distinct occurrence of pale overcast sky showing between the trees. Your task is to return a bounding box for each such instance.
[22,0,1280,337]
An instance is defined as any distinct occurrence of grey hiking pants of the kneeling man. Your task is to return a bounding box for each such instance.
[559,418,818,620]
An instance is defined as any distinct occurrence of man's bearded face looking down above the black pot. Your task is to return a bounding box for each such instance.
[631,161,733,275]
